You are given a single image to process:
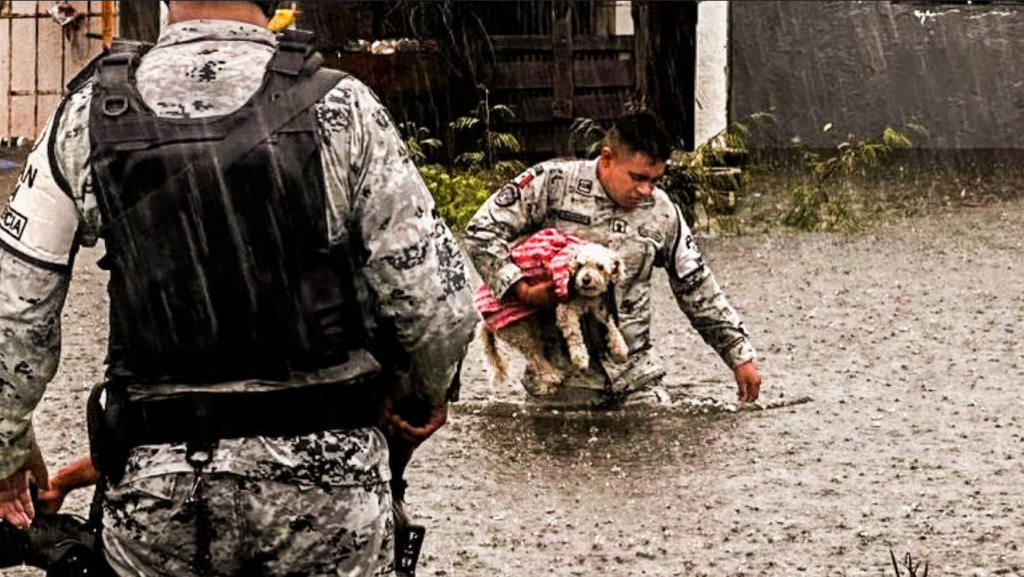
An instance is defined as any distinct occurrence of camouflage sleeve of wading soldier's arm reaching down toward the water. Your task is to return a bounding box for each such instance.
[660,201,757,369]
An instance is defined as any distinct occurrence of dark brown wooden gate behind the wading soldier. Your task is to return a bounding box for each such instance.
[486,2,636,155]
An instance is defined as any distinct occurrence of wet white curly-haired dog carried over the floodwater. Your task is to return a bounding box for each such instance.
[479,243,629,397]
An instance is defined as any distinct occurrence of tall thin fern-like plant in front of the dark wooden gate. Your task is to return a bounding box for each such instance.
[451,88,525,177]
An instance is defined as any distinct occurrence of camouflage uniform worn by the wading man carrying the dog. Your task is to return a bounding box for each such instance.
[466,155,755,401]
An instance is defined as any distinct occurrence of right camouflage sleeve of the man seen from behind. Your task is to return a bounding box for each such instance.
[317,79,478,406]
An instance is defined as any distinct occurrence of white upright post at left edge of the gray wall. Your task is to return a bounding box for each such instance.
[693,1,729,146]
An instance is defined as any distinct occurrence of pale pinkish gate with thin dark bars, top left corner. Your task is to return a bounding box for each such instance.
[0,0,117,139]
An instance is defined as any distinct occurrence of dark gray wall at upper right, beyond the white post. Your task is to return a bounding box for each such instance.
[729,1,1024,150]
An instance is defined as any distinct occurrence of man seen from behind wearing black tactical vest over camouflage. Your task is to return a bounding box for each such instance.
[0,1,477,576]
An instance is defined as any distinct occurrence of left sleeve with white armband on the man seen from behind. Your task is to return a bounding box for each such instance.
[0,99,79,478]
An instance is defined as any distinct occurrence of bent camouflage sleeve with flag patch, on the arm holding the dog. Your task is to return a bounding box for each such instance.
[465,164,548,300]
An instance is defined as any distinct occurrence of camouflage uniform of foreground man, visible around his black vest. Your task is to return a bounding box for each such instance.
[0,20,478,575]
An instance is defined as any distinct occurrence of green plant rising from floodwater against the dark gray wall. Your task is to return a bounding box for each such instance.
[782,122,923,231]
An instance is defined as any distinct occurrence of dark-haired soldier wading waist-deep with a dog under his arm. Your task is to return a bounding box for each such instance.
[466,113,761,405]
